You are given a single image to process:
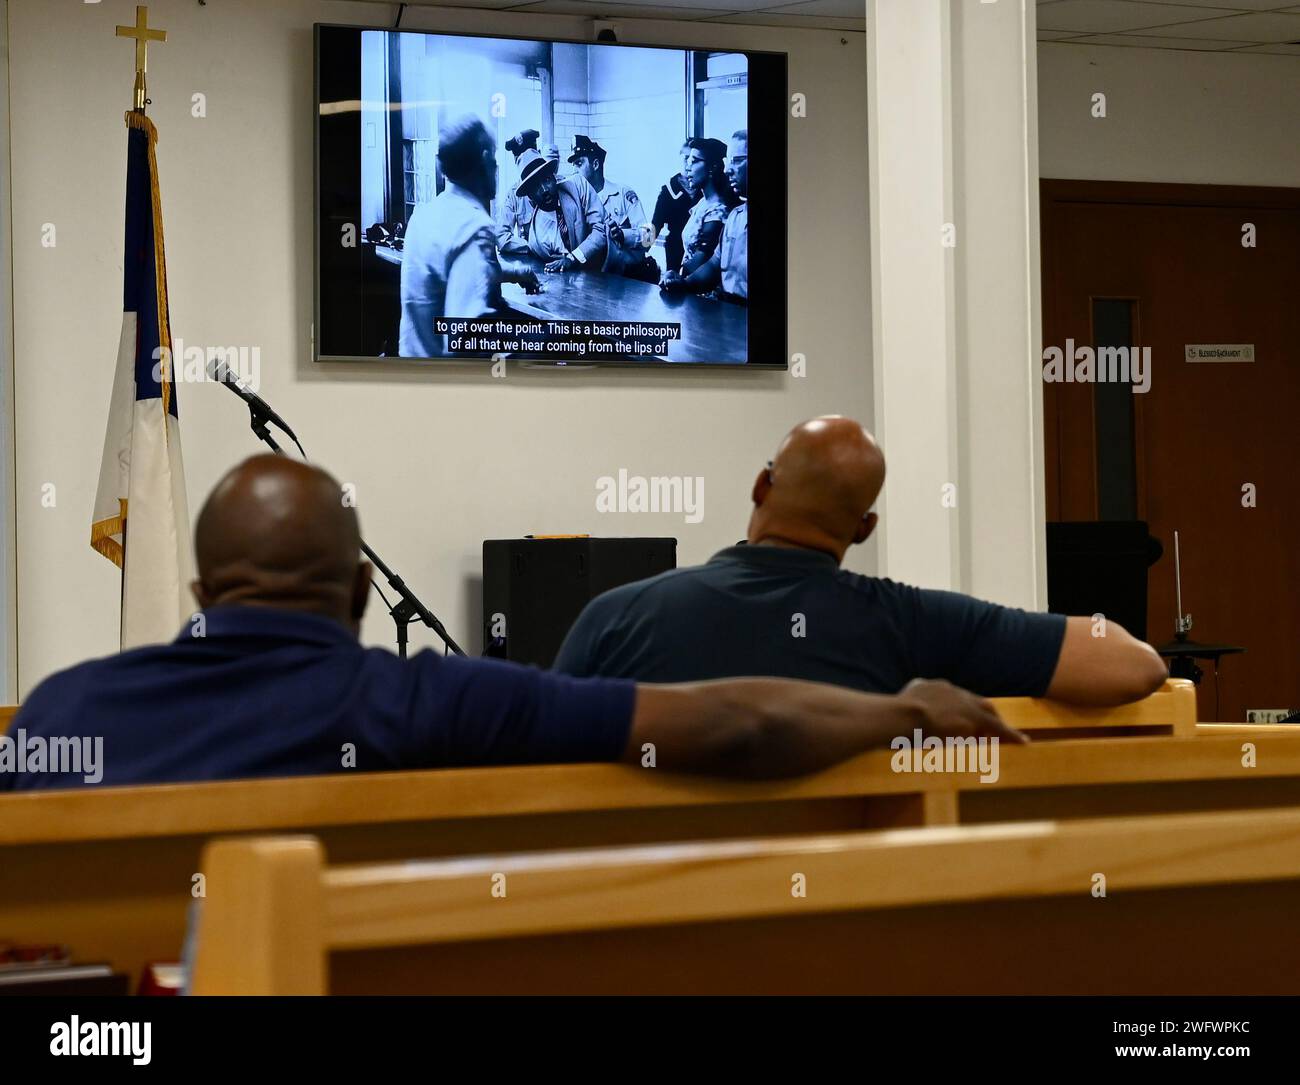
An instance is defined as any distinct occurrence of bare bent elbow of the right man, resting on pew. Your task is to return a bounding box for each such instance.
[1048,617,1169,704]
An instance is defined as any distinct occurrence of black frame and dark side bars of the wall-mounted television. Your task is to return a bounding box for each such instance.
[311,22,790,373]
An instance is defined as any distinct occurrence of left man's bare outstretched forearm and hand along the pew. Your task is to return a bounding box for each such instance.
[623,678,1027,780]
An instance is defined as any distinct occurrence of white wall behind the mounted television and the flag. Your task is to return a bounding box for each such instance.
[9,0,872,695]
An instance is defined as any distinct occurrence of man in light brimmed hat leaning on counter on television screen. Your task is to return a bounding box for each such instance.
[515,151,608,272]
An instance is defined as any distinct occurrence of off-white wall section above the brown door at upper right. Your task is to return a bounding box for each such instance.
[1039,43,1300,187]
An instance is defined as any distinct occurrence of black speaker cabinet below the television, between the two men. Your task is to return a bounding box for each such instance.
[484,538,677,667]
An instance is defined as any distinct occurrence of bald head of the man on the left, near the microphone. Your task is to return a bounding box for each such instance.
[194,455,371,633]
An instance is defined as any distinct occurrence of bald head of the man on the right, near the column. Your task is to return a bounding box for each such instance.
[749,415,885,560]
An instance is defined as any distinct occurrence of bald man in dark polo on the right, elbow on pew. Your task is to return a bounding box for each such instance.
[555,416,1169,704]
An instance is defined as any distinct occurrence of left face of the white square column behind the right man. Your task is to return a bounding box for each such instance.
[867,0,959,587]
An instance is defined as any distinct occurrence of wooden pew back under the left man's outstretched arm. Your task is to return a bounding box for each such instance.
[0,685,1279,975]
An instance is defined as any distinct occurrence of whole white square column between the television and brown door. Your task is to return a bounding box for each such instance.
[867,0,1047,607]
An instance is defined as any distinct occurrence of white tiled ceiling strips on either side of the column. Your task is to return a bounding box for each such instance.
[364,0,1300,56]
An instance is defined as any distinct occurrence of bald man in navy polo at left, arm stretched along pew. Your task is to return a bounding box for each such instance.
[0,456,1022,790]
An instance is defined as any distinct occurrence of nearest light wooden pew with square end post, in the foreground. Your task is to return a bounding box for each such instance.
[194,810,1300,994]
